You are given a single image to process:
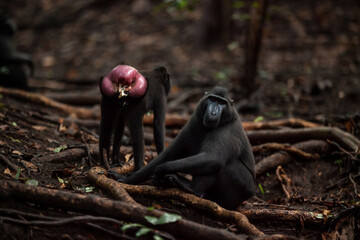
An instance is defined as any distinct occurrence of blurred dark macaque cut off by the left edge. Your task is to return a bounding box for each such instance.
[0,13,34,89]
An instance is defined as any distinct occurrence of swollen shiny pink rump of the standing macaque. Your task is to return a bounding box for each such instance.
[100,65,148,98]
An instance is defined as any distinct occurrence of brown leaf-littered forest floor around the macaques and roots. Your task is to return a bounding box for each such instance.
[0,0,360,239]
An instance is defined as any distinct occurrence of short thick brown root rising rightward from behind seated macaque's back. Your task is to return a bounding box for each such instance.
[255,140,331,176]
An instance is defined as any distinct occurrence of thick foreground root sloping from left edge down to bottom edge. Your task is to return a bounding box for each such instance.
[0,180,250,240]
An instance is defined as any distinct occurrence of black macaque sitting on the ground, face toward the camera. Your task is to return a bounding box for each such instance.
[110,87,255,209]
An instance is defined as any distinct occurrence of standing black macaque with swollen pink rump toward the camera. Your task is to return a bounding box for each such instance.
[99,65,170,170]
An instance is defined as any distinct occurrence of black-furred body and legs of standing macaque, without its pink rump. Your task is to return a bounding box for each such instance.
[99,67,170,170]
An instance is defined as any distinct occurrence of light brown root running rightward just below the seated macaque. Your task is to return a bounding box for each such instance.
[88,167,263,236]
